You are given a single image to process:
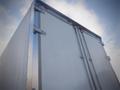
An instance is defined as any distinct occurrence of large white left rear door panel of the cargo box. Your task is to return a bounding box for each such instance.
[41,13,90,90]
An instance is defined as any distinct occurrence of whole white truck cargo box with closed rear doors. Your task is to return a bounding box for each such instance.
[0,0,120,90]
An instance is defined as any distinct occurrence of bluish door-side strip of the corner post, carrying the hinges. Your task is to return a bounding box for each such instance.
[33,2,42,90]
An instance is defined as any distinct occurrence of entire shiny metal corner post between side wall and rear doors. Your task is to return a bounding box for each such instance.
[26,0,44,90]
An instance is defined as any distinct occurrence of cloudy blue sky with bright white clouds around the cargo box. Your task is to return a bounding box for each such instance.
[0,0,120,80]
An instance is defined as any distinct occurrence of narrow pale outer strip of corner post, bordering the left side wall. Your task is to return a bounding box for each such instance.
[26,2,34,90]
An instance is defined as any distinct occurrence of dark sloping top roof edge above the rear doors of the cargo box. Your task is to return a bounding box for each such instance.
[35,0,101,39]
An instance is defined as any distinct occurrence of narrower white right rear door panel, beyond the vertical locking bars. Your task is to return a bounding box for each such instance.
[83,33,119,90]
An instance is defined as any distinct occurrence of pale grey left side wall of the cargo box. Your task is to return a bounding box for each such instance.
[0,3,31,90]
